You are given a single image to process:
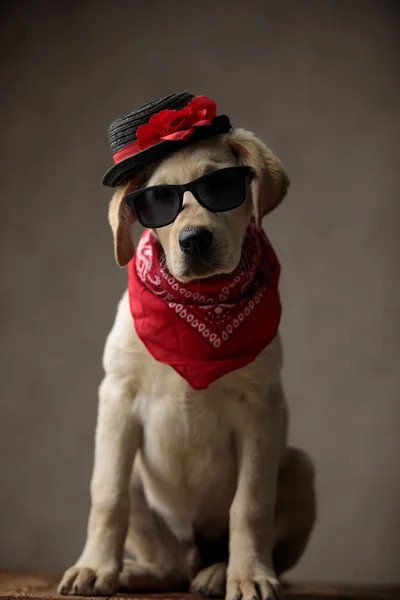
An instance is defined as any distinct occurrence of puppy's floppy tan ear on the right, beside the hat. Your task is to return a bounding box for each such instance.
[227,129,290,228]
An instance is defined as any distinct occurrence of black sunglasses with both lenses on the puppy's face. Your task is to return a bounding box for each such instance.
[125,167,254,229]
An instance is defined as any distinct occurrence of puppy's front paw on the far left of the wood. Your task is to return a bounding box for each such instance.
[58,566,118,596]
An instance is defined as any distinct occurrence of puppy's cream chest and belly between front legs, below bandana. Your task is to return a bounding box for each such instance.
[137,364,239,524]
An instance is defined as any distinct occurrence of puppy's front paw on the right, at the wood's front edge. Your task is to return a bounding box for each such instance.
[226,569,283,600]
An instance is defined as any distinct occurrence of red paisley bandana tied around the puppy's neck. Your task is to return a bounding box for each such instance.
[128,223,281,390]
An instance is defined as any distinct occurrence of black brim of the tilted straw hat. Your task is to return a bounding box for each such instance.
[102,115,232,187]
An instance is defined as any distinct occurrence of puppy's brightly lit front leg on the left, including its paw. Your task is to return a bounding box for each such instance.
[59,375,141,595]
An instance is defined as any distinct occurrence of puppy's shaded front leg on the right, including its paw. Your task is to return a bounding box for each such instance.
[226,386,283,600]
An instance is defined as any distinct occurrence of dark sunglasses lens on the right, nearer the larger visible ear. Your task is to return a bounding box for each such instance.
[197,167,249,212]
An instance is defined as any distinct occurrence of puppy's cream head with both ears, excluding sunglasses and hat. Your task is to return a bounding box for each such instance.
[109,129,289,281]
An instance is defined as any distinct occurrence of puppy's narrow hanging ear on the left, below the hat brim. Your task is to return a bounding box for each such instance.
[108,176,141,267]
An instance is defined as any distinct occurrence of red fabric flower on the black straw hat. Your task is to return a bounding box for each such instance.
[136,96,217,150]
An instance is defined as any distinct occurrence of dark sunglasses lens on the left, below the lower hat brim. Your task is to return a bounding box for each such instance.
[135,186,179,229]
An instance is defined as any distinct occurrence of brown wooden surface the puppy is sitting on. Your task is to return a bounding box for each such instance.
[0,572,400,600]
